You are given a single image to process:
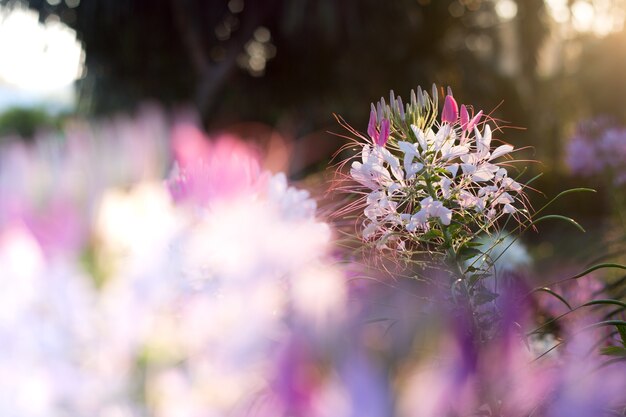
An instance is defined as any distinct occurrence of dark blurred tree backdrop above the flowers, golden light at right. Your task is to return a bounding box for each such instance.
[0,0,626,239]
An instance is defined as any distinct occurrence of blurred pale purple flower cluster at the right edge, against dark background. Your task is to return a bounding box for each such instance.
[566,117,626,186]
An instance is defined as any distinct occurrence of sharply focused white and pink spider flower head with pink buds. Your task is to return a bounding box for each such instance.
[350,86,528,254]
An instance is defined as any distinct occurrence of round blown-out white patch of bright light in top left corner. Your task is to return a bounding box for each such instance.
[0,3,84,92]
